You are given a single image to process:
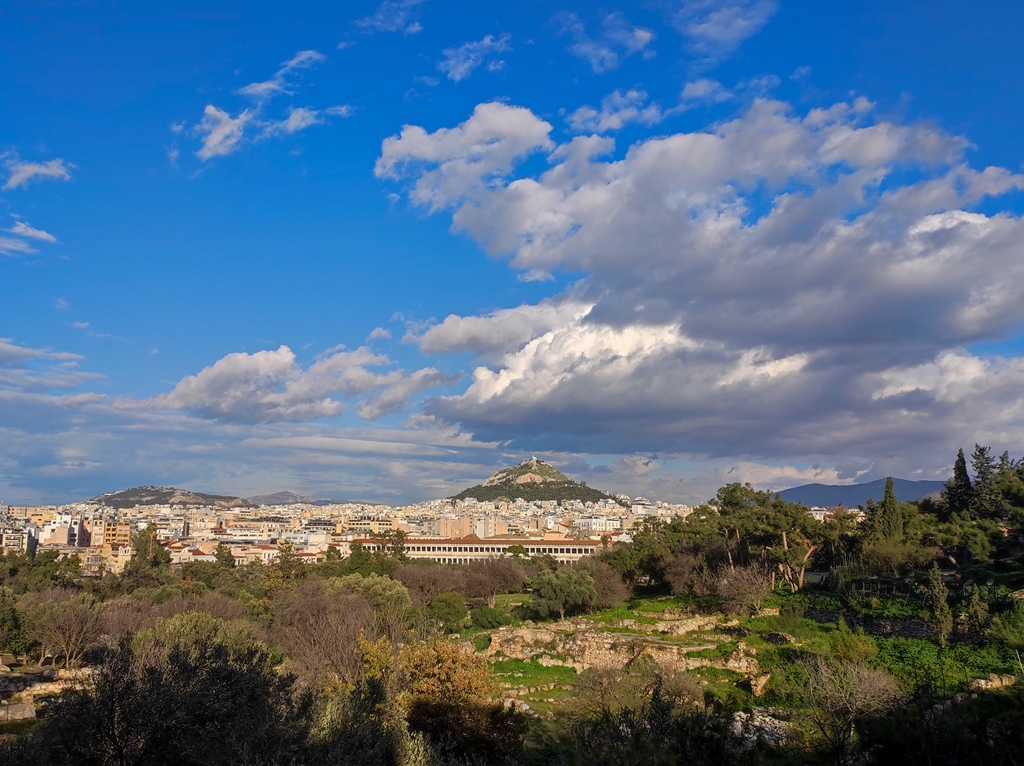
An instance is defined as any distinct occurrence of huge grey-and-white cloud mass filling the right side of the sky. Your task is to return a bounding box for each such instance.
[379,97,1024,470]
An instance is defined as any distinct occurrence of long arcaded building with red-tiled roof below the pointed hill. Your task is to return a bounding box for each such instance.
[358,537,601,564]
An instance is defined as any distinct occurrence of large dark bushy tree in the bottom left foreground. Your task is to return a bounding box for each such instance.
[33,614,310,766]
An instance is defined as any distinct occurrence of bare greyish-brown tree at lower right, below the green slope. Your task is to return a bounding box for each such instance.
[796,655,904,766]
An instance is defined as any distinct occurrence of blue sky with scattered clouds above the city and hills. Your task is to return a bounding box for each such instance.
[0,0,1024,504]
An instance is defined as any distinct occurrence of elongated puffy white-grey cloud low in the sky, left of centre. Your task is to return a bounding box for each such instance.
[144,346,452,423]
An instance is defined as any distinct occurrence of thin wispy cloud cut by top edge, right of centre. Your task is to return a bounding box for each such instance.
[672,0,778,63]
